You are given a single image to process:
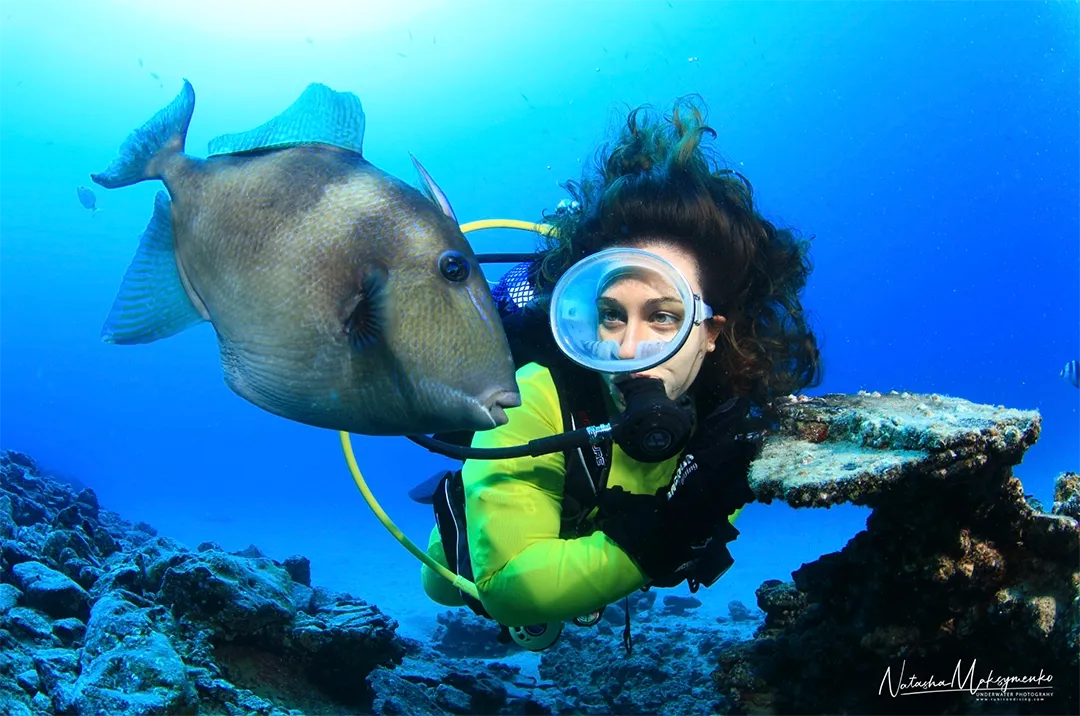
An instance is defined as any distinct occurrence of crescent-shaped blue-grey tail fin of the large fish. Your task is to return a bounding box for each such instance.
[90,80,195,189]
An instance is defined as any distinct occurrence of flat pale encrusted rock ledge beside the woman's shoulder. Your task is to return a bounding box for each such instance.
[751,391,1041,508]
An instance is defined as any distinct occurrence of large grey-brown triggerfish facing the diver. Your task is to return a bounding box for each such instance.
[91,80,521,435]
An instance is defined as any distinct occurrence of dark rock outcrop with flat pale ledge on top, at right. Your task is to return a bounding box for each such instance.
[713,392,1080,716]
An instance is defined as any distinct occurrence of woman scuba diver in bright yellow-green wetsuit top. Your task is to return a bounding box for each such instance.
[410,98,821,650]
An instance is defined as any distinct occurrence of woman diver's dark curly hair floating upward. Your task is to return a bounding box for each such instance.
[536,95,821,406]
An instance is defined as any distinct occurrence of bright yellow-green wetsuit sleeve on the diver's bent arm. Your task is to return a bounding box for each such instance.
[462,364,646,626]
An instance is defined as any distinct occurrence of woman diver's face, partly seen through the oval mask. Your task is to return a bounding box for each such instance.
[596,242,725,408]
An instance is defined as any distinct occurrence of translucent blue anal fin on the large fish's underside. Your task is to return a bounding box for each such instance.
[102,191,204,345]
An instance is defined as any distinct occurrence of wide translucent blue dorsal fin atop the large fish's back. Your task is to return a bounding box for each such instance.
[208,82,366,157]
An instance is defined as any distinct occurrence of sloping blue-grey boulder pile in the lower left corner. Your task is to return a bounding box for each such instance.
[0,450,405,716]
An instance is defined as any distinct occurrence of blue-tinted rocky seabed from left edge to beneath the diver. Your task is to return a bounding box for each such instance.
[0,451,759,716]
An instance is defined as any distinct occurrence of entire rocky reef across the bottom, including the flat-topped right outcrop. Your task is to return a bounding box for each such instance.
[0,386,1080,716]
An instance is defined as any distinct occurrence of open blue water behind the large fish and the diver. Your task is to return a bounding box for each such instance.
[0,0,1080,632]
